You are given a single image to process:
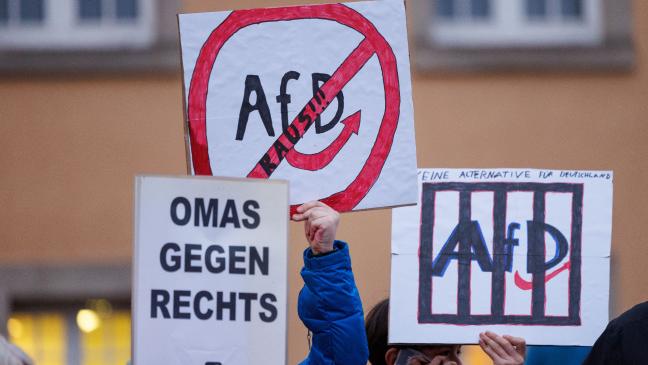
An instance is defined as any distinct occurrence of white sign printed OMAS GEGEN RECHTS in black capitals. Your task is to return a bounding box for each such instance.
[132,176,288,365]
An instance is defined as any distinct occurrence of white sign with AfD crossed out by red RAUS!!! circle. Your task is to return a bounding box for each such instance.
[179,1,416,211]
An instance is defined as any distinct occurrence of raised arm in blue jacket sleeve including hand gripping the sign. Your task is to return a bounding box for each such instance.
[292,201,369,365]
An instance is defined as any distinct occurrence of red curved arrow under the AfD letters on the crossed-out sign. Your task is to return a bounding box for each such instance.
[286,111,361,171]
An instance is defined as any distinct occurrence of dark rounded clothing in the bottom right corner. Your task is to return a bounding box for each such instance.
[583,302,648,365]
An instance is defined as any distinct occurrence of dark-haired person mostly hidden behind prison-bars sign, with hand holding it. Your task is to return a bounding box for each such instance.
[366,299,526,365]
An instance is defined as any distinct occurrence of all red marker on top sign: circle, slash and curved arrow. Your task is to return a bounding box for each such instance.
[187,4,401,212]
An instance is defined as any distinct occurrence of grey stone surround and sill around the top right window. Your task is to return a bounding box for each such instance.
[407,0,635,72]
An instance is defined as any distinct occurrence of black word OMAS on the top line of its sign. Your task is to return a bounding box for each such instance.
[170,196,261,229]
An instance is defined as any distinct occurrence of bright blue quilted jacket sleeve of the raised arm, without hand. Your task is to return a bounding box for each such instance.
[298,241,369,365]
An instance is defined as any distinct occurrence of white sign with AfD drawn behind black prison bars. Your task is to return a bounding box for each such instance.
[389,169,612,345]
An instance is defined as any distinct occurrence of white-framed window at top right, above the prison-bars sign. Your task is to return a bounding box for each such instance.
[429,0,603,47]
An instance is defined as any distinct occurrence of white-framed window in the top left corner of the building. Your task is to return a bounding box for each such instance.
[0,0,160,51]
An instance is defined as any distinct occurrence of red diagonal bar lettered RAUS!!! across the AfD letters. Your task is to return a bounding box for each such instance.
[247,38,375,179]
